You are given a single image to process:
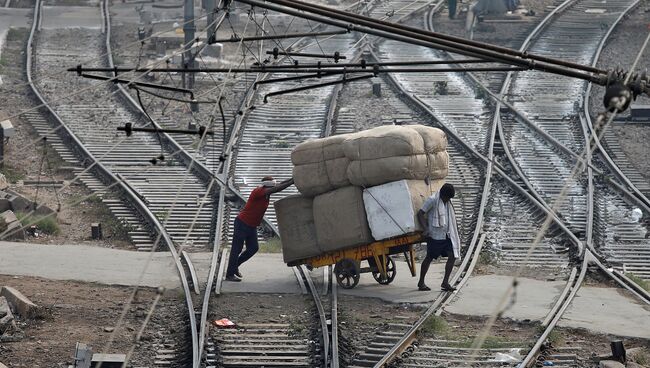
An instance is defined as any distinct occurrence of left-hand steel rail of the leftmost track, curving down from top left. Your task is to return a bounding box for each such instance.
[26,0,197,366]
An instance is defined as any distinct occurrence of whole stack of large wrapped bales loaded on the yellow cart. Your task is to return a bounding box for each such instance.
[276,125,449,262]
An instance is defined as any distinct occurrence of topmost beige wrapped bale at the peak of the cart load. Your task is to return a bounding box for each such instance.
[343,125,424,161]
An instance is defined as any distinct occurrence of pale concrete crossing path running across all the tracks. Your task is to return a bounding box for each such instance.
[0,241,650,338]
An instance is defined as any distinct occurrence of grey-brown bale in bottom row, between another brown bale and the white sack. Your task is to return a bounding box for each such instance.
[314,186,373,251]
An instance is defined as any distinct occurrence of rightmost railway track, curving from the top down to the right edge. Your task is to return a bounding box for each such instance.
[492,1,650,277]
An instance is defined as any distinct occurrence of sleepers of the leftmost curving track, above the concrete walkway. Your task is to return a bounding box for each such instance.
[27,2,214,250]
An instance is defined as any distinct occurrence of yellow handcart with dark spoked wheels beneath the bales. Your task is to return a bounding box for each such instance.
[300,233,424,289]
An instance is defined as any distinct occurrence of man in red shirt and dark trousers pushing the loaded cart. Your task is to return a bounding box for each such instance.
[226,176,293,281]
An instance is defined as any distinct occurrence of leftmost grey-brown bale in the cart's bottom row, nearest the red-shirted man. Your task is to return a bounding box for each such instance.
[273,195,322,263]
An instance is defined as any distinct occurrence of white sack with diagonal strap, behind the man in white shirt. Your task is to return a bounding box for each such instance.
[363,180,444,240]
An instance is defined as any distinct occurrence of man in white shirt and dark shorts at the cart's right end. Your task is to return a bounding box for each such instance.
[418,184,460,291]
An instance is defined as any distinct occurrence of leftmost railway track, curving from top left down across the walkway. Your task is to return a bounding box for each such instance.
[22,0,229,367]
